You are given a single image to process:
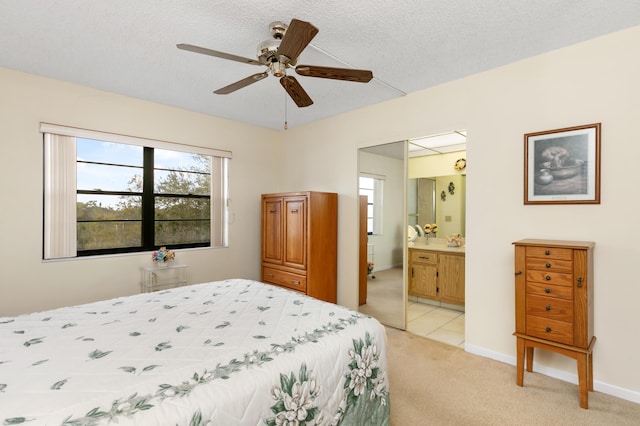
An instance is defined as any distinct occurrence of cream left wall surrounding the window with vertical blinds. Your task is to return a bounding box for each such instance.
[0,68,281,316]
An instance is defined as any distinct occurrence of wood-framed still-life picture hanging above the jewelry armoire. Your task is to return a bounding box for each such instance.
[524,123,600,204]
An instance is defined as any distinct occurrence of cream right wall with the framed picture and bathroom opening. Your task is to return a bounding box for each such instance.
[283,27,640,402]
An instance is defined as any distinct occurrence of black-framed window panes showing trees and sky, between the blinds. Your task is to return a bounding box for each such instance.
[76,138,212,255]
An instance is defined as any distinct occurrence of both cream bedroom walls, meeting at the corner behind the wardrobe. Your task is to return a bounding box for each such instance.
[0,27,640,402]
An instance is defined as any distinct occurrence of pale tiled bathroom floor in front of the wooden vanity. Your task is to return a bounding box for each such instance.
[407,301,464,348]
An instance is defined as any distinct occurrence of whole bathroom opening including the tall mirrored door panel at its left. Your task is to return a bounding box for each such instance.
[358,132,466,346]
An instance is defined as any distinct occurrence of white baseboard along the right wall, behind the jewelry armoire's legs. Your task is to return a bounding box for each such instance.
[464,343,640,404]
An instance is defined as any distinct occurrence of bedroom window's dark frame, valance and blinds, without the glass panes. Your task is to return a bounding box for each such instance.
[40,123,231,260]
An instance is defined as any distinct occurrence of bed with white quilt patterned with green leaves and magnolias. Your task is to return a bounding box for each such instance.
[0,279,389,426]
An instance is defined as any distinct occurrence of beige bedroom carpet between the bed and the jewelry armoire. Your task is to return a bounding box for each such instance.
[384,327,640,426]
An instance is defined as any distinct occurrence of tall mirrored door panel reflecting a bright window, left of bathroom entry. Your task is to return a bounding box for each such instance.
[358,141,407,330]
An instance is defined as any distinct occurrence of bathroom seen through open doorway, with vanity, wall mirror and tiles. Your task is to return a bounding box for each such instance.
[406,132,466,347]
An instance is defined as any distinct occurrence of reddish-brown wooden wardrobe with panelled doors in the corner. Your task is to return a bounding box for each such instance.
[261,191,338,303]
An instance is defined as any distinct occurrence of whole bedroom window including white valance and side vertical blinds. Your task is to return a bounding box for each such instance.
[41,124,230,259]
